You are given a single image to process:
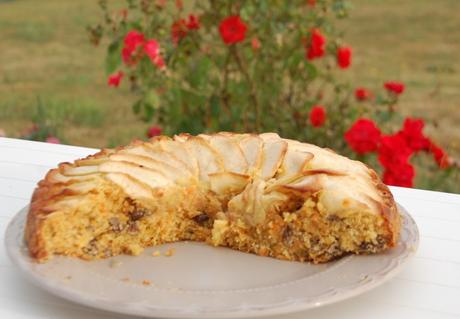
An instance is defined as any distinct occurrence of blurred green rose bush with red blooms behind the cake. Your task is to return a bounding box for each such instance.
[88,0,455,190]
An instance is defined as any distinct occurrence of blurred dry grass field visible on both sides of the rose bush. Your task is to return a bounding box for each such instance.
[0,0,460,192]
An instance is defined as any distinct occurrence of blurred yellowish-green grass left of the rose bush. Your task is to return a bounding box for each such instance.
[0,0,147,147]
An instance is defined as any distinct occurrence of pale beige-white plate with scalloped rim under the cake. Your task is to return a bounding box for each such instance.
[5,207,419,318]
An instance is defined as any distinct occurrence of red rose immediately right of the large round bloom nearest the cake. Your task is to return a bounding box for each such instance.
[378,134,413,169]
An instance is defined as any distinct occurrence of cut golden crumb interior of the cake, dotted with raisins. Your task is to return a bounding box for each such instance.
[34,179,390,263]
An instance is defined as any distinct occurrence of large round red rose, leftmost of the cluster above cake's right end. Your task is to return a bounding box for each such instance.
[345,118,381,154]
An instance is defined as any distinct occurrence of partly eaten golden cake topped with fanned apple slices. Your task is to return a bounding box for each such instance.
[25,132,400,263]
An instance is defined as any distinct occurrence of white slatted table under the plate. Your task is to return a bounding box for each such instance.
[0,138,460,319]
